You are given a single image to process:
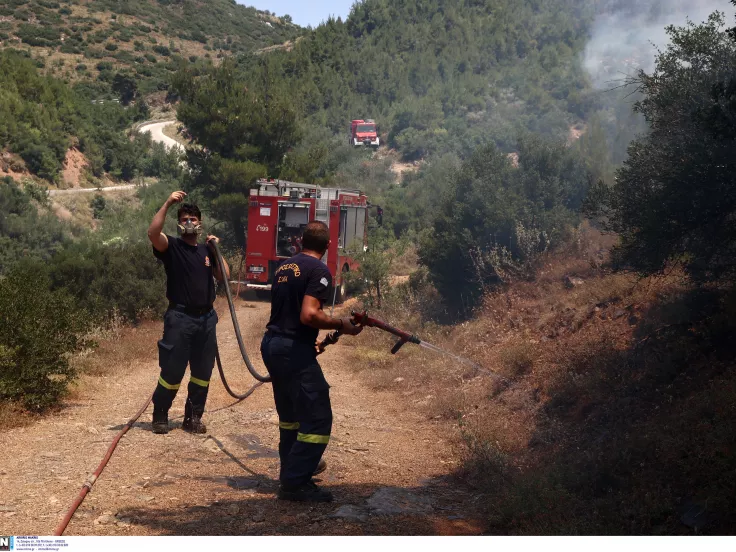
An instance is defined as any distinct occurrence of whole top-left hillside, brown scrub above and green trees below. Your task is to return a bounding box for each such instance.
[0,0,300,187]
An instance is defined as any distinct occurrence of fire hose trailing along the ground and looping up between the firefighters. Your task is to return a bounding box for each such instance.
[54,241,271,537]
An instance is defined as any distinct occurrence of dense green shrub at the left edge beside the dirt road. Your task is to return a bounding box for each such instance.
[0,263,89,410]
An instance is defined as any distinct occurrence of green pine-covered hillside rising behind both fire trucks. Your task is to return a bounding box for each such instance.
[174,0,612,258]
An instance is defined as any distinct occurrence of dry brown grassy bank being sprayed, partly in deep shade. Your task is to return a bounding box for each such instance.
[356,223,736,534]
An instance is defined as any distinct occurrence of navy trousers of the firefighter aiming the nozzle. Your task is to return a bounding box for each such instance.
[261,332,332,488]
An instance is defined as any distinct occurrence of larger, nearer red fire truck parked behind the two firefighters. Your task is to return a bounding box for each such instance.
[240,180,368,303]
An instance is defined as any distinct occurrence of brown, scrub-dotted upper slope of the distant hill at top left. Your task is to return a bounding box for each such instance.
[0,0,300,90]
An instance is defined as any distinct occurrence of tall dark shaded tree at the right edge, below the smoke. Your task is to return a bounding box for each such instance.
[596,14,736,281]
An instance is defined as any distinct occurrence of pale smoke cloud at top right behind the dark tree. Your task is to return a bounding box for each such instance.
[584,0,734,88]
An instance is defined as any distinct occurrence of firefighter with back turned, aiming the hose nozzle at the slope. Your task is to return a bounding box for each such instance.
[261,221,362,502]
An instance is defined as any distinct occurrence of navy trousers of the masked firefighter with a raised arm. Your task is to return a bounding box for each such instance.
[153,309,217,418]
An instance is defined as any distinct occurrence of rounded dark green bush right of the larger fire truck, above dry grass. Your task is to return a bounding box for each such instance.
[419,136,589,314]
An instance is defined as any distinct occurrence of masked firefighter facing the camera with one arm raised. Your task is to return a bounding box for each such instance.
[148,192,230,433]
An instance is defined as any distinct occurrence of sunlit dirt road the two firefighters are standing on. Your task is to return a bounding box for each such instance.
[0,302,480,535]
